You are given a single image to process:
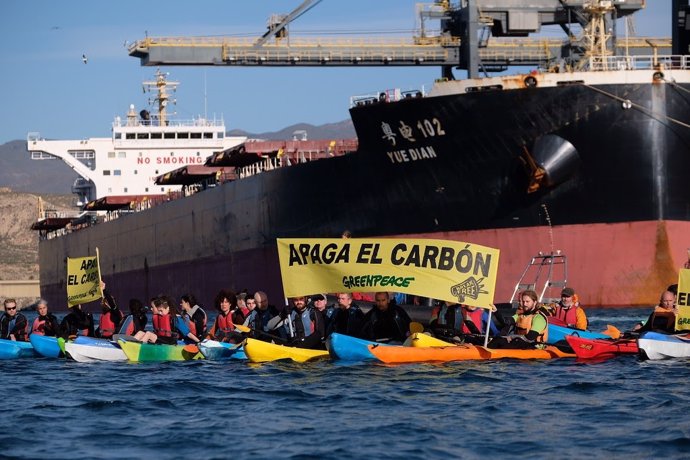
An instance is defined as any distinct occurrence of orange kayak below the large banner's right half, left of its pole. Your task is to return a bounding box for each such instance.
[369,344,482,364]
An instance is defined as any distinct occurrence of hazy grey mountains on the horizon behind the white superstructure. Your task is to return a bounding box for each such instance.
[0,120,356,195]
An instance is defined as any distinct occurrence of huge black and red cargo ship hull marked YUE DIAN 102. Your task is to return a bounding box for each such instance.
[28,2,690,306]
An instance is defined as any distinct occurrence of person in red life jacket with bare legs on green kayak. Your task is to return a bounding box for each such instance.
[134,296,199,345]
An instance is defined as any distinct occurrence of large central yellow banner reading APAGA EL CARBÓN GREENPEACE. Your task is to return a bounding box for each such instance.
[278,238,500,308]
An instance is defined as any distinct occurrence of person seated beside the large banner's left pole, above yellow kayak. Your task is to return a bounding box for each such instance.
[282,296,326,349]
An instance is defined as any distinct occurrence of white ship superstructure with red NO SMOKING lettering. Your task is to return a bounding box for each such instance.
[27,71,246,204]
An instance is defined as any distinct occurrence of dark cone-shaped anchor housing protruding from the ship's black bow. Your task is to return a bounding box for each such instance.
[532,134,580,187]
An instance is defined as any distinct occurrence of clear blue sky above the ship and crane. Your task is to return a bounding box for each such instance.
[0,0,671,144]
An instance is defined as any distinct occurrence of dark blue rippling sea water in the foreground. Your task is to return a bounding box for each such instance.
[0,309,690,459]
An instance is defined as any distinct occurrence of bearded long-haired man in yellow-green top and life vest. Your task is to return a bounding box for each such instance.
[489,290,549,349]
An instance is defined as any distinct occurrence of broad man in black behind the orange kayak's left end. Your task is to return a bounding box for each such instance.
[360,292,411,343]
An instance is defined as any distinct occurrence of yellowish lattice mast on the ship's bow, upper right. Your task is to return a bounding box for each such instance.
[579,0,615,70]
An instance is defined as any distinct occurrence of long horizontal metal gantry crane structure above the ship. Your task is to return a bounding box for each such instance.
[129,0,671,78]
